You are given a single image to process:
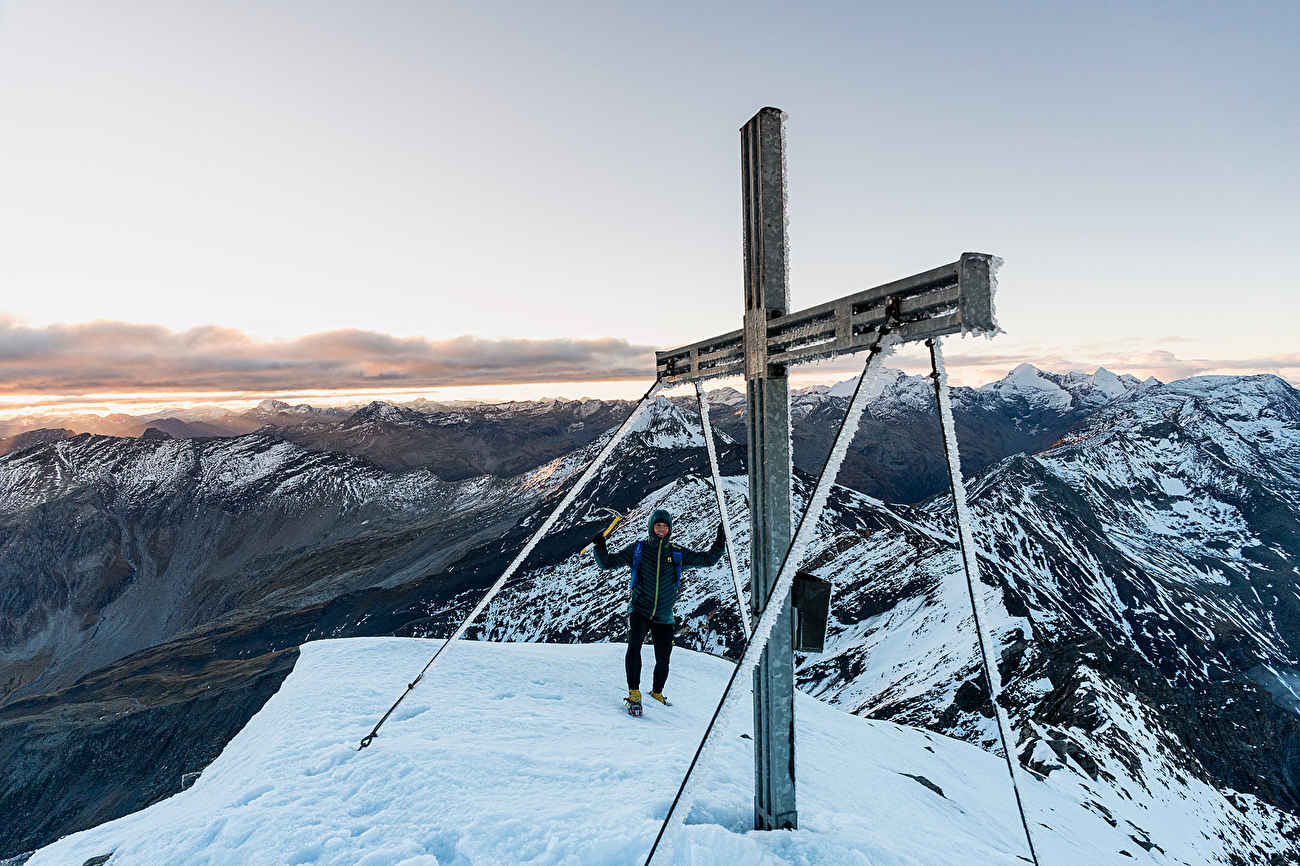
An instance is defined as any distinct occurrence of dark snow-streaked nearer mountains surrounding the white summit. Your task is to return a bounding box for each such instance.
[0,371,1300,863]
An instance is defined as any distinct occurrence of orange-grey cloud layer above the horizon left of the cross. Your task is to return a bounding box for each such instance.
[0,319,654,394]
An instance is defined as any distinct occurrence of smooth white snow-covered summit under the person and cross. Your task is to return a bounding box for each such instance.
[29,638,1170,866]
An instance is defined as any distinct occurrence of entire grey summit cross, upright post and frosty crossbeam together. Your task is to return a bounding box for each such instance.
[655,108,997,830]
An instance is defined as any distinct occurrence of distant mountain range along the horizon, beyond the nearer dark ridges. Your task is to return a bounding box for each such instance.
[0,364,1154,503]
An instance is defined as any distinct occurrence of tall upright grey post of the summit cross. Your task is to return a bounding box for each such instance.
[741,108,798,830]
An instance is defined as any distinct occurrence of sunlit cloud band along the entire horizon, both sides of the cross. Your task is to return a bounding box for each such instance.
[0,313,1300,406]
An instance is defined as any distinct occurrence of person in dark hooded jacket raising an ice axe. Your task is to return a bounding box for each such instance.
[592,508,727,715]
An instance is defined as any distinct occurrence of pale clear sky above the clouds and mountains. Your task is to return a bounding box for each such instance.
[0,0,1300,397]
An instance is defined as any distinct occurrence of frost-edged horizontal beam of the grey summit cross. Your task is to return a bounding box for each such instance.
[655,252,997,384]
